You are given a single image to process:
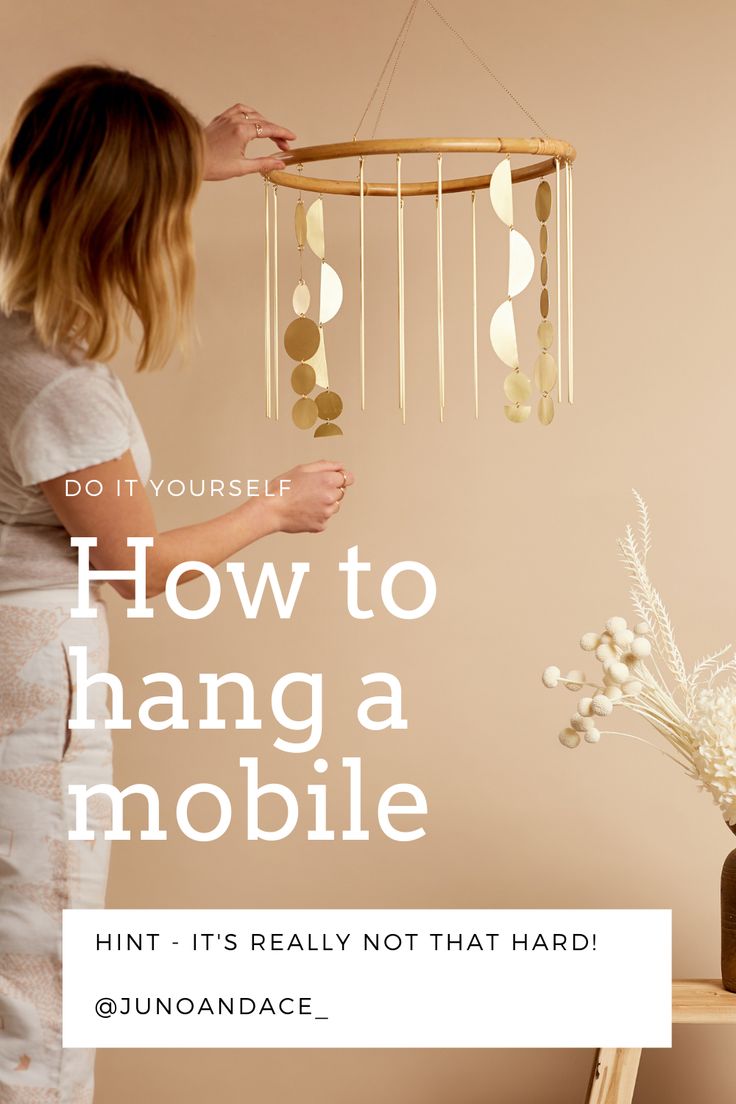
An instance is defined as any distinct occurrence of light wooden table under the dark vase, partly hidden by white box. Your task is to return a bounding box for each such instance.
[585,978,736,1104]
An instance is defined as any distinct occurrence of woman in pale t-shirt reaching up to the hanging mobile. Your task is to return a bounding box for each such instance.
[0,66,352,1104]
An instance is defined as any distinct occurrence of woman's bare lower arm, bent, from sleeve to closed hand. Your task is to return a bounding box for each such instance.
[41,452,353,598]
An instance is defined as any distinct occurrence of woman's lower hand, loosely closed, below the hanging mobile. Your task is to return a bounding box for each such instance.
[266,460,355,533]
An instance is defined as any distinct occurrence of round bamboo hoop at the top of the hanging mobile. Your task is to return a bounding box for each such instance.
[267,138,576,198]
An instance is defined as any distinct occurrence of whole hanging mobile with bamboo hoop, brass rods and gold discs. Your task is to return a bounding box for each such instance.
[265,0,576,436]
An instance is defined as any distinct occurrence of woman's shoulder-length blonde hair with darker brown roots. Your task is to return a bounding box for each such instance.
[0,65,203,371]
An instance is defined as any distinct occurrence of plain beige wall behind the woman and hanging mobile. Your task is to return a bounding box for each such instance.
[2,0,736,1104]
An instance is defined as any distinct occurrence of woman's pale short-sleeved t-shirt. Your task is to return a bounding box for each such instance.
[0,311,151,592]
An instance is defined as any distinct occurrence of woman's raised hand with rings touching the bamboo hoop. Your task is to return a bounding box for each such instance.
[203,104,297,180]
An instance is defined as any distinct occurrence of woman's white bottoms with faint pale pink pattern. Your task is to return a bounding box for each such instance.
[0,591,113,1104]
